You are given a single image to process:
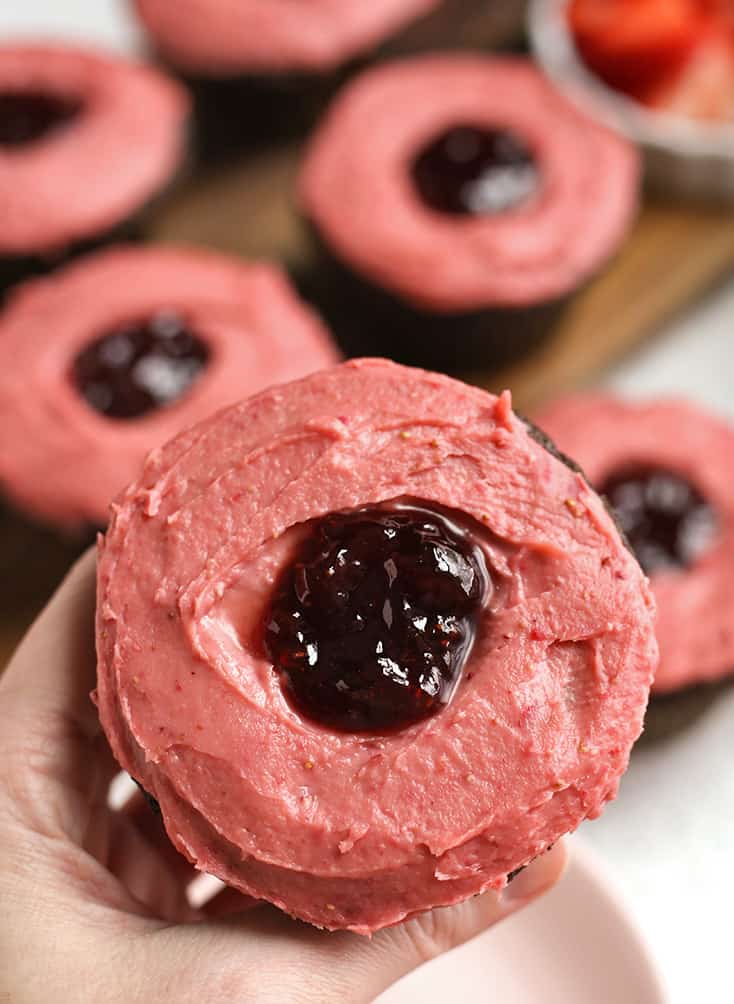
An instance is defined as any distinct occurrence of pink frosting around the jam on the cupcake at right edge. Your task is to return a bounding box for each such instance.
[537,395,734,692]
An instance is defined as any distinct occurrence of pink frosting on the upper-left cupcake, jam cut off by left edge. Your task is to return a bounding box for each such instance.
[0,45,189,255]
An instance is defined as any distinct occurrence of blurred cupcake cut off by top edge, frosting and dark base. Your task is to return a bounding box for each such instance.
[136,0,518,156]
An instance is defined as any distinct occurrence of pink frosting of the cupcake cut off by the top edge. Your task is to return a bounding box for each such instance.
[135,0,435,75]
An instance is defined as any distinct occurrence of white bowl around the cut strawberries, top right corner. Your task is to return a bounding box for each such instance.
[528,0,734,202]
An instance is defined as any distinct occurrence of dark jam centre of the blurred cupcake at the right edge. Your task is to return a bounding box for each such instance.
[599,467,717,575]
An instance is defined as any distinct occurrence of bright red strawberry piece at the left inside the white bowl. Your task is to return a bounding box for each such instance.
[569,0,710,96]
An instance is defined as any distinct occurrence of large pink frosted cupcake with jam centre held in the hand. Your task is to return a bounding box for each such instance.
[95,360,657,934]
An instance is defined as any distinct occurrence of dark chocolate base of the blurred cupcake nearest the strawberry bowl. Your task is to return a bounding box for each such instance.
[295,235,571,373]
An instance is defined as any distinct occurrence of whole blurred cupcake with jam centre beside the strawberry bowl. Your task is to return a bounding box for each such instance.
[299,55,638,369]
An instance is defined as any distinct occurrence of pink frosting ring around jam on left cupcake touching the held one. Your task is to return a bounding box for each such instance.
[0,246,338,525]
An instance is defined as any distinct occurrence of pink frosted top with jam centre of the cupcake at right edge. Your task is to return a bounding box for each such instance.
[538,395,734,694]
